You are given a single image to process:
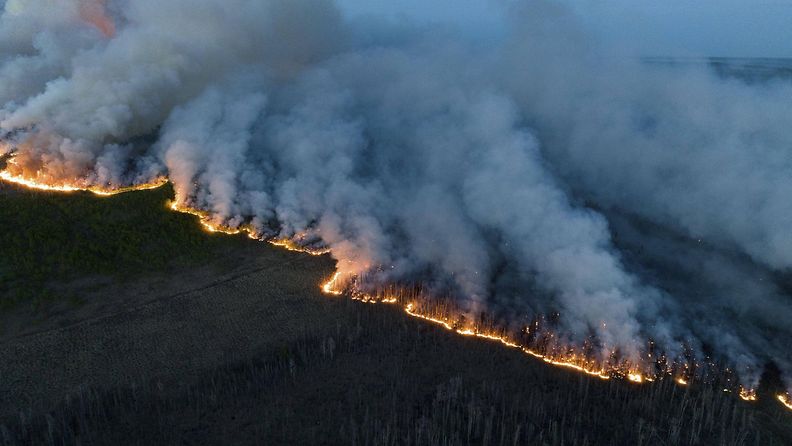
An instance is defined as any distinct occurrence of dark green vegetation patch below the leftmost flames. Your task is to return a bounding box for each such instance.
[0,183,241,309]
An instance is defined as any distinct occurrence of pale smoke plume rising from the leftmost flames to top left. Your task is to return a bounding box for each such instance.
[0,0,340,184]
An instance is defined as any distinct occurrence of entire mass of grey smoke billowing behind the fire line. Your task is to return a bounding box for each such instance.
[0,0,792,385]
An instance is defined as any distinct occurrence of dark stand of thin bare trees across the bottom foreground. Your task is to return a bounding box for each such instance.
[0,301,792,446]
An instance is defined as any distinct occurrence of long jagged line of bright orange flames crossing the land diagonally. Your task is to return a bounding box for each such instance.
[0,169,792,410]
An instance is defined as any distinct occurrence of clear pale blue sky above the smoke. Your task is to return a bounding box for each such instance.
[338,0,792,57]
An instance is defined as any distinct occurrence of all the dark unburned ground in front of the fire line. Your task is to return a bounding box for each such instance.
[0,181,792,445]
